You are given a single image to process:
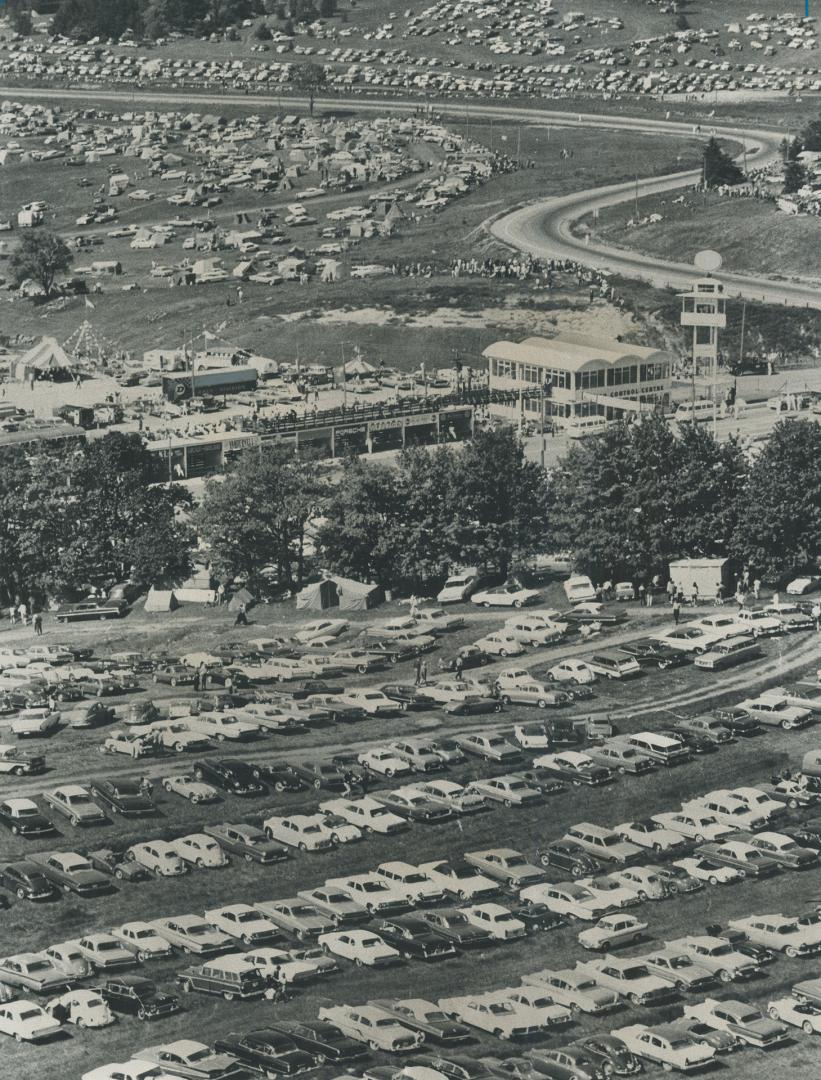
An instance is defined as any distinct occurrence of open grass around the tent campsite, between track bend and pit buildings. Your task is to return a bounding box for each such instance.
[0,113,700,367]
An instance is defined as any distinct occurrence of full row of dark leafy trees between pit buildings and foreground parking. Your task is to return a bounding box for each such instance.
[0,416,821,599]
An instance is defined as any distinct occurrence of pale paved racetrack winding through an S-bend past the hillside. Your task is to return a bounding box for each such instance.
[0,86,821,308]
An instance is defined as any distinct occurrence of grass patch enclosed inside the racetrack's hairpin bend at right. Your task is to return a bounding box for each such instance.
[583,191,821,279]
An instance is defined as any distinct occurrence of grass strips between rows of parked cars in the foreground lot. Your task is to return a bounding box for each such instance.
[1,586,818,1080]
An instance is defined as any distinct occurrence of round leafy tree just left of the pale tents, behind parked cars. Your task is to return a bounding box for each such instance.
[194,448,324,590]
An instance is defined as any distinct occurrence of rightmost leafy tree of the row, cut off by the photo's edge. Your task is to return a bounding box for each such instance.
[736,420,821,582]
